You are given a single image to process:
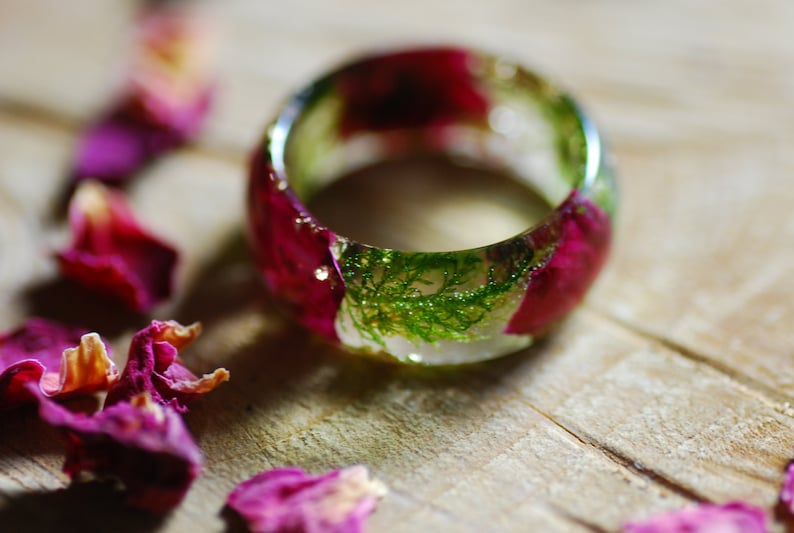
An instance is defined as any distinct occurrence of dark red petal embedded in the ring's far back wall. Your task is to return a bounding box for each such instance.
[338,48,489,136]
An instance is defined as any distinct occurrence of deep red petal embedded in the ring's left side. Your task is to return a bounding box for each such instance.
[248,154,345,341]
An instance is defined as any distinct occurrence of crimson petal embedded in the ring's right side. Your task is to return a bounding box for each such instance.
[505,191,611,334]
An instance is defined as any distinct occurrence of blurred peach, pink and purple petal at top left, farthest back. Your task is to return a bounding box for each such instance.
[74,7,215,182]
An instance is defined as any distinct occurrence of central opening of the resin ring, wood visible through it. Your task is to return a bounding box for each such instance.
[307,154,551,251]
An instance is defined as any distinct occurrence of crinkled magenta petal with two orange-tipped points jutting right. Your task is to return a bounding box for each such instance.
[105,320,229,412]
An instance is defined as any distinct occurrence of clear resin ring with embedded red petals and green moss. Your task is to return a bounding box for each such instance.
[248,47,616,364]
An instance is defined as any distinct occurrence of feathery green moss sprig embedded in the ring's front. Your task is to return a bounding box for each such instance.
[332,239,550,347]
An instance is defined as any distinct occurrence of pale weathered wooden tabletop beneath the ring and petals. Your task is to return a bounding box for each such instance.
[0,0,794,532]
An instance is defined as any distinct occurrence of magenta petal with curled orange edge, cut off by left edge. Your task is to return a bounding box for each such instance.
[0,318,119,410]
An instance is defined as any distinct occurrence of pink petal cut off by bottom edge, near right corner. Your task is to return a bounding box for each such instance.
[623,502,767,533]
